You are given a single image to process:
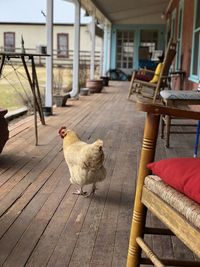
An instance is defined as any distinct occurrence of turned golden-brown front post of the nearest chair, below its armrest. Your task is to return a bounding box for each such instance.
[127,114,159,267]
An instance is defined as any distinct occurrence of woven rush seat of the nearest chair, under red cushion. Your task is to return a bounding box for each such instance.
[144,175,200,229]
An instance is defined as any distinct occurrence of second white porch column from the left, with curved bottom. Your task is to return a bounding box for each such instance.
[70,0,80,97]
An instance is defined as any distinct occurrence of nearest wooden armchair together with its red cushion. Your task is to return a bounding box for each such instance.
[127,100,200,267]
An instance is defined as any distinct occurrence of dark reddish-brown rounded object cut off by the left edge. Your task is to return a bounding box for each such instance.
[0,108,9,153]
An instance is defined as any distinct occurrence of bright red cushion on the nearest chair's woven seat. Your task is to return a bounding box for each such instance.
[147,158,200,203]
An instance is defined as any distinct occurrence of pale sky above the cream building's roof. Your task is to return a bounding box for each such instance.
[0,0,90,23]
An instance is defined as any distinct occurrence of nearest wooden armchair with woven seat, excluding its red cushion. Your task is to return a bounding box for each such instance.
[127,101,200,267]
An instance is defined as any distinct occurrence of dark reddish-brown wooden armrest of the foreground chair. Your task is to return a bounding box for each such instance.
[136,99,200,120]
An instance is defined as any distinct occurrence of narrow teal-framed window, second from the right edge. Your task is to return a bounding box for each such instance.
[176,0,183,70]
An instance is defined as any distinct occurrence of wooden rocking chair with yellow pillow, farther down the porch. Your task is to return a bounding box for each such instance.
[128,40,176,103]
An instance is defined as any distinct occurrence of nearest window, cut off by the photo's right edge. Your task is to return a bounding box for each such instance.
[191,0,200,82]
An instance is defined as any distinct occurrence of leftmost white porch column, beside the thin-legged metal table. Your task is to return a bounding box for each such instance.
[44,0,53,116]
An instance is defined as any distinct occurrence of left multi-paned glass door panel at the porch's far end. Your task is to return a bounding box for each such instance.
[117,31,134,69]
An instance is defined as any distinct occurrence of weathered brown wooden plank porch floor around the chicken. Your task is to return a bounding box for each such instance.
[0,82,195,267]
